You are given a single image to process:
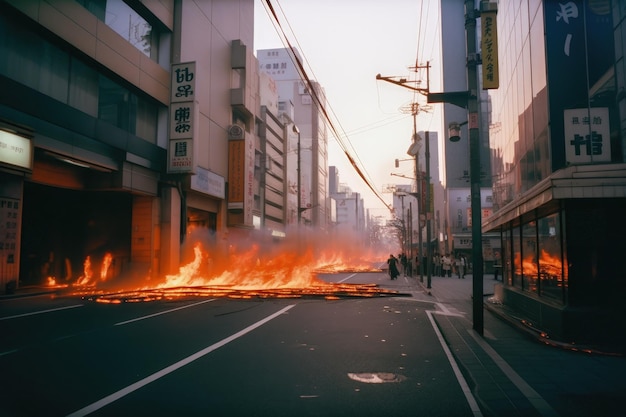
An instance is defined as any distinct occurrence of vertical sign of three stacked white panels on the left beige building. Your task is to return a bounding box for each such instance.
[167,62,198,173]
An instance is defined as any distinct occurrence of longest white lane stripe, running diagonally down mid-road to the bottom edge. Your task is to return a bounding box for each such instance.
[67,304,295,417]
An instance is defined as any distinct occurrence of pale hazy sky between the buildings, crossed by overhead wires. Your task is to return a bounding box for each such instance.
[254,0,441,218]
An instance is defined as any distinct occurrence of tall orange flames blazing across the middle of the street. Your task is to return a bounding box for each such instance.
[70,229,397,303]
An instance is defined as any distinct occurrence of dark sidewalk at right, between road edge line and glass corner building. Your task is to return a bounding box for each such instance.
[413,275,626,417]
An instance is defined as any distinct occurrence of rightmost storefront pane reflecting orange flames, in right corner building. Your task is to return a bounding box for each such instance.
[537,213,567,302]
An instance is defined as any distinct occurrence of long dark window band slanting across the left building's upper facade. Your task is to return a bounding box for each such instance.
[0,4,159,143]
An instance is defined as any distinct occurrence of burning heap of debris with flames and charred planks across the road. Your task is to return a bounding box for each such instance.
[61,231,406,303]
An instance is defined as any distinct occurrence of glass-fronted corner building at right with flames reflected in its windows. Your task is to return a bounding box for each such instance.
[478,0,626,343]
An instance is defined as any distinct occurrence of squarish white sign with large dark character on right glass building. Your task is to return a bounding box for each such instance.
[564,107,611,164]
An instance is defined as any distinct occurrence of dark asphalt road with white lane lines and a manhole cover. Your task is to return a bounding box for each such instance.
[0,273,476,417]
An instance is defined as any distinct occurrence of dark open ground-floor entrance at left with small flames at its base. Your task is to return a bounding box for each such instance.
[20,182,132,286]
